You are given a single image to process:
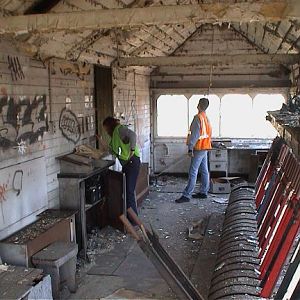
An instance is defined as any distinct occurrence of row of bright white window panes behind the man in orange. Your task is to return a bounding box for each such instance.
[157,94,285,139]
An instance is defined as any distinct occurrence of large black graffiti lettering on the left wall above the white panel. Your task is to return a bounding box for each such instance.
[0,95,47,150]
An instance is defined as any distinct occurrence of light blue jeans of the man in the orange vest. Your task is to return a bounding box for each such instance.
[182,150,209,199]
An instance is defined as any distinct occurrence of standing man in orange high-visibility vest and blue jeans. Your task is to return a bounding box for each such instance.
[175,98,212,203]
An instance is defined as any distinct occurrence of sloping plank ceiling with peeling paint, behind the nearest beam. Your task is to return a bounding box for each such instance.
[0,0,300,65]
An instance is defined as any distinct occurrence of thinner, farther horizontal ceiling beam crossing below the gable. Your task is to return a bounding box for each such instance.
[118,54,300,67]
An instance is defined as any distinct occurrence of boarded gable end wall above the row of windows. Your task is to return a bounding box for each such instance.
[151,24,290,91]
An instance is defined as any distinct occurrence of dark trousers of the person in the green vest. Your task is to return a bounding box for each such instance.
[123,155,141,221]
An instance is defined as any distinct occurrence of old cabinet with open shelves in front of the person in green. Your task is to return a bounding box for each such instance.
[57,161,126,257]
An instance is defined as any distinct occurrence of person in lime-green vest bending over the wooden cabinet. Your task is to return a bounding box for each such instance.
[103,117,141,223]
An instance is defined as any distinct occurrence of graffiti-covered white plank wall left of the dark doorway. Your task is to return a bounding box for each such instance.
[0,43,95,237]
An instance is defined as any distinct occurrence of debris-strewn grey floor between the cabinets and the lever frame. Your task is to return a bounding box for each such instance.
[70,177,227,299]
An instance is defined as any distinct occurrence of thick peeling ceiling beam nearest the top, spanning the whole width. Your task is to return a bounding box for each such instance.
[0,0,300,34]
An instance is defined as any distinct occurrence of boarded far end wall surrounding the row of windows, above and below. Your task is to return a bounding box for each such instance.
[150,25,290,173]
